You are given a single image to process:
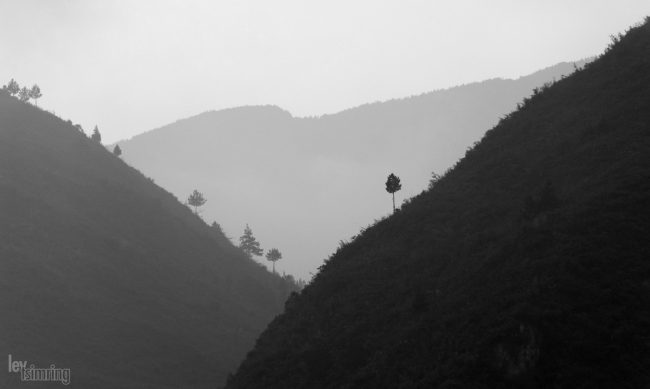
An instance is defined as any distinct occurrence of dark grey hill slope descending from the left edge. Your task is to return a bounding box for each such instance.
[0,92,292,388]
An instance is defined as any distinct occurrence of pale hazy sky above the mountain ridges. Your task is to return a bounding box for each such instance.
[0,0,650,142]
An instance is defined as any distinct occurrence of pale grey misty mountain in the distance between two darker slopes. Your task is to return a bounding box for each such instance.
[119,61,585,278]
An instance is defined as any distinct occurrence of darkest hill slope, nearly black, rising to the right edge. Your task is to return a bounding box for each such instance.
[227,22,650,389]
